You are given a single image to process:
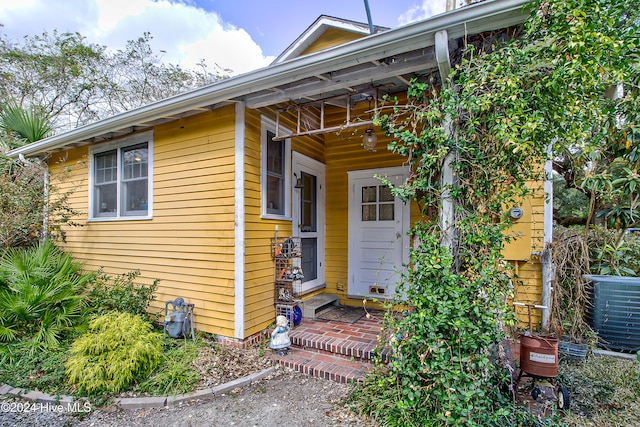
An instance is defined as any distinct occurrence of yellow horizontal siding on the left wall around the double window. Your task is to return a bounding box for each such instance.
[51,106,235,337]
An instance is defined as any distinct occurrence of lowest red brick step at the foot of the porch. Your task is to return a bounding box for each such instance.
[273,347,372,384]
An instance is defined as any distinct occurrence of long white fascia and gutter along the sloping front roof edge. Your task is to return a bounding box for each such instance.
[8,0,529,158]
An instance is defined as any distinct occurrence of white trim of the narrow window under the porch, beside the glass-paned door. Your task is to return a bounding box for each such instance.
[260,116,291,221]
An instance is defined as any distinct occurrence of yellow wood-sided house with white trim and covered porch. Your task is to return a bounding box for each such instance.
[10,0,550,342]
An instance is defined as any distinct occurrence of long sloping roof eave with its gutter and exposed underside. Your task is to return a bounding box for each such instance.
[9,0,529,157]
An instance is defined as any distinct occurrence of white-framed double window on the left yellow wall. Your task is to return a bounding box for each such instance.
[89,133,153,219]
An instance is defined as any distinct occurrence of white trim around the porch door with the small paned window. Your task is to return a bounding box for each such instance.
[347,166,411,299]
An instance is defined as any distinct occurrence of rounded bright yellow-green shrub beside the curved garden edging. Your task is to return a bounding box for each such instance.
[65,313,163,394]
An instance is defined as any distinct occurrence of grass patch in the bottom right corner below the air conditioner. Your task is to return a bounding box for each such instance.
[559,357,640,427]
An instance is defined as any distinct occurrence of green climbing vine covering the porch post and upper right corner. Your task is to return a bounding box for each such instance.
[358,0,639,426]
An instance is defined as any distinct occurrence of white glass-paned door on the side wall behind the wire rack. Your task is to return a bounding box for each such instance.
[292,152,325,293]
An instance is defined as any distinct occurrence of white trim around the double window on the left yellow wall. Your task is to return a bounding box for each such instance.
[87,131,153,222]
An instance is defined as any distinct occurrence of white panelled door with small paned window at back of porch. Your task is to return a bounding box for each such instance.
[349,167,410,299]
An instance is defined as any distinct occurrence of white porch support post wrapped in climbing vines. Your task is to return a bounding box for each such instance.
[435,30,456,250]
